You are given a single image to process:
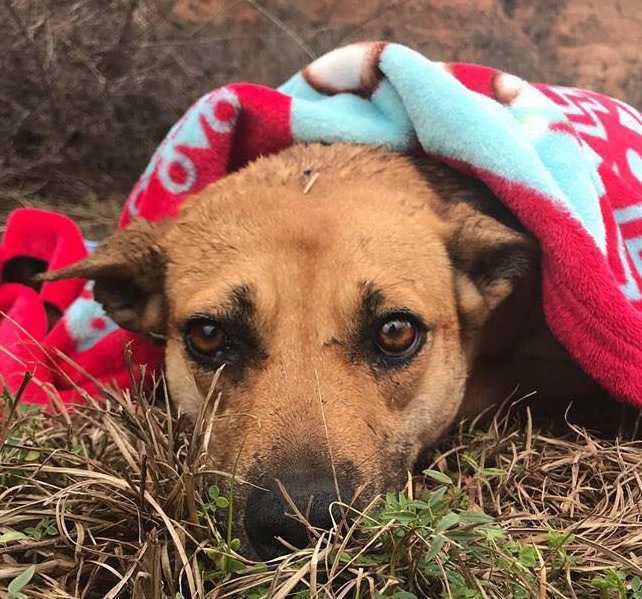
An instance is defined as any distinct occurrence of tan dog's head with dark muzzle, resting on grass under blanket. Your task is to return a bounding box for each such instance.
[45,145,534,557]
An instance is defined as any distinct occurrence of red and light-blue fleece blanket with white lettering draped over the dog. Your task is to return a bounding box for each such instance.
[0,42,642,407]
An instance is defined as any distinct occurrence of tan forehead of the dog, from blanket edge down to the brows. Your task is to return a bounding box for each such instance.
[166,146,451,324]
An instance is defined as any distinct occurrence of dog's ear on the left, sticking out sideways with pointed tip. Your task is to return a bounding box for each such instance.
[35,220,166,334]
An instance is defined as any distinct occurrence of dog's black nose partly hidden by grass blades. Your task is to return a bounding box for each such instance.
[245,473,352,560]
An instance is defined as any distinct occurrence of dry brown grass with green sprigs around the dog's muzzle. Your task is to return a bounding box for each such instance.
[0,368,642,598]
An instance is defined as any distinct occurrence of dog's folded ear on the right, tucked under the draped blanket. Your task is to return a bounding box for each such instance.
[446,200,538,335]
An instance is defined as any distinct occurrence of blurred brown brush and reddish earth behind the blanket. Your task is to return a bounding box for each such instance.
[0,0,642,237]
